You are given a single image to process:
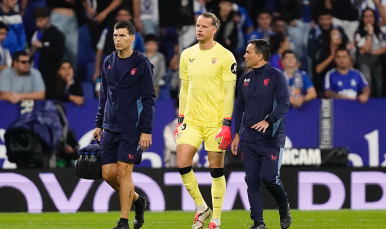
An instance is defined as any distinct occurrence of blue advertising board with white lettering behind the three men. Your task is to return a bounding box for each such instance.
[0,99,386,168]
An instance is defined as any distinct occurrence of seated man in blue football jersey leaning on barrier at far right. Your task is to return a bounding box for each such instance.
[324,48,370,103]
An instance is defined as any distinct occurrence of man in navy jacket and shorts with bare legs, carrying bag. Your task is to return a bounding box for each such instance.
[93,21,155,229]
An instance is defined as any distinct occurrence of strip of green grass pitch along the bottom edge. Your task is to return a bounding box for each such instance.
[0,210,386,229]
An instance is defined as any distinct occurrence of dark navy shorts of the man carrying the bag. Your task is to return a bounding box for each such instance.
[101,130,143,165]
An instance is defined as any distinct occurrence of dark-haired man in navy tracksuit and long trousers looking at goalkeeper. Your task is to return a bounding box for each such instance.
[232,40,291,229]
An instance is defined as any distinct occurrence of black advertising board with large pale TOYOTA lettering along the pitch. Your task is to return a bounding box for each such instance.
[0,167,386,213]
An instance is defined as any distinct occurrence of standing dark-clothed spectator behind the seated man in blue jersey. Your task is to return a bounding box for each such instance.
[308,9,348,96]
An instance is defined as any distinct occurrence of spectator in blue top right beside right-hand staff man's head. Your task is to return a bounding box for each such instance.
[282,50,316,108]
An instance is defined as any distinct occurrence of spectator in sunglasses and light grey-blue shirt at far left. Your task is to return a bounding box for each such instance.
[0,51,46,104]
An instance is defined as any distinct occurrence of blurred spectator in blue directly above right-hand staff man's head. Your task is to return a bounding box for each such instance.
[247,9,275,41]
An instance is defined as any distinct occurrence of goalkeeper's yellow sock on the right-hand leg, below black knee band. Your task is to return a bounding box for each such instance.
[212,176,226,219]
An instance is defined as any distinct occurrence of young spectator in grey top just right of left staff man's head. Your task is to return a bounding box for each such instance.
[143,34,166,97]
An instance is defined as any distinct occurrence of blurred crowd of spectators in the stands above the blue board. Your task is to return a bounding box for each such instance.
[0,0,386,168]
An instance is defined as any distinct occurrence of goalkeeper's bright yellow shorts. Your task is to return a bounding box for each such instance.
[177,123,223,152]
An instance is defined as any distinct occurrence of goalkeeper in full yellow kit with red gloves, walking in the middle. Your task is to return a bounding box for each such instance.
[175,13,237,229]
